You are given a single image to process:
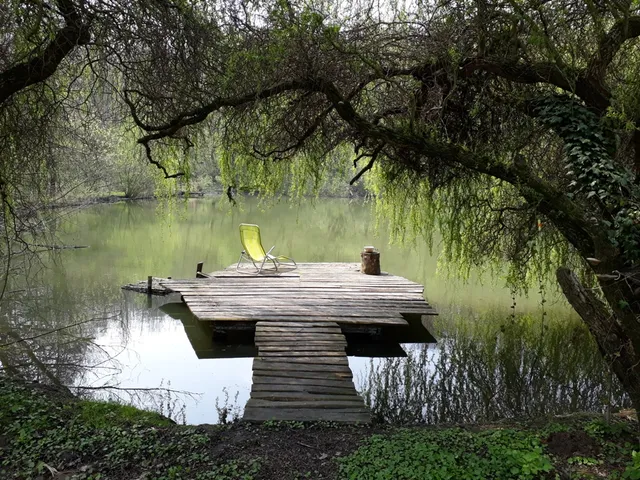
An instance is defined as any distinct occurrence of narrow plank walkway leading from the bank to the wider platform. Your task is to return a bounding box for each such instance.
[243,322,370,423]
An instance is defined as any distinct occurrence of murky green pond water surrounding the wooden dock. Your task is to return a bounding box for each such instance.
[0,198,626,424]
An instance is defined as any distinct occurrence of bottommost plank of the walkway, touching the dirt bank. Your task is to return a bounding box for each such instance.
[243,407,371,424]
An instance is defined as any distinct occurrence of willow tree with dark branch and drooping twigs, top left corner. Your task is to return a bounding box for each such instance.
[0,0,200,274]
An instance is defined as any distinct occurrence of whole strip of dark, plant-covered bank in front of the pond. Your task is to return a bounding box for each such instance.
[0,377,640,480]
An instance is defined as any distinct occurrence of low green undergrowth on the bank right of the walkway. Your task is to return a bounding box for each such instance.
[338,416,640,480]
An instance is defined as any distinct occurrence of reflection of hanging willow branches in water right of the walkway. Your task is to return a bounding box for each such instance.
[358,311,628,423]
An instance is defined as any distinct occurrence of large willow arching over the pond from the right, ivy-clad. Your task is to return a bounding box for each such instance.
[117,0,640,408]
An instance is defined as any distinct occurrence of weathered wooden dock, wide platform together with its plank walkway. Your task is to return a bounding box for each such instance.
[162,263,436,423]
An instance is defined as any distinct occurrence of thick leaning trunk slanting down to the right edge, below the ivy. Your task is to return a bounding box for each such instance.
[556,268,640,418]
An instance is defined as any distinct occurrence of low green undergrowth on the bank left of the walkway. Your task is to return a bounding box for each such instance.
[0,377,259,480]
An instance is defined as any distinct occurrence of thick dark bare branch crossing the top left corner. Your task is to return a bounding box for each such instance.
[0,0,91,105]
